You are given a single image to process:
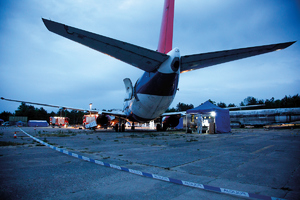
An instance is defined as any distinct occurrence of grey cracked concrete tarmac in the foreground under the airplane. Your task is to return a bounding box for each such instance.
[0,127,300,199]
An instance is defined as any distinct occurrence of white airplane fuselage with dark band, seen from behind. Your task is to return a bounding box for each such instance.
[124,48,180,122]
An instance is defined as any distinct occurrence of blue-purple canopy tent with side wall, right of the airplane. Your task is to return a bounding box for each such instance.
[186,101,231,133]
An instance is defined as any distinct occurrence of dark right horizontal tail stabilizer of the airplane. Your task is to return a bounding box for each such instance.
[180,41,295,73]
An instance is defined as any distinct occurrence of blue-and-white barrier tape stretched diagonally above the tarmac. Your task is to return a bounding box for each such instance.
[20,128,284,200]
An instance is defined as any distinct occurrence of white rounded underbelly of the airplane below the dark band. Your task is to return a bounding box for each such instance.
[132,94,174,119]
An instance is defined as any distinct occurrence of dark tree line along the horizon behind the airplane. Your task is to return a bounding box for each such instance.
[0,94,300,124]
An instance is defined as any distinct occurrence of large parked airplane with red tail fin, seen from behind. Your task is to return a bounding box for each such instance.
[0,0,296,131]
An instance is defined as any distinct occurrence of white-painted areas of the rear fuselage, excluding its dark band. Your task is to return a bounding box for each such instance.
[124,48,180,121]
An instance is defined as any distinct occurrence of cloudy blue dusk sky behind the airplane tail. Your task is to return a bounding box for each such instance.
[0,0,300,113]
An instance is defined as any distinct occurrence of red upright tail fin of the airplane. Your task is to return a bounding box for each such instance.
[157,0,175,54]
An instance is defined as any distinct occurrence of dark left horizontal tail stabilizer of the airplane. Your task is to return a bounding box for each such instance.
[43,19,169,72]
